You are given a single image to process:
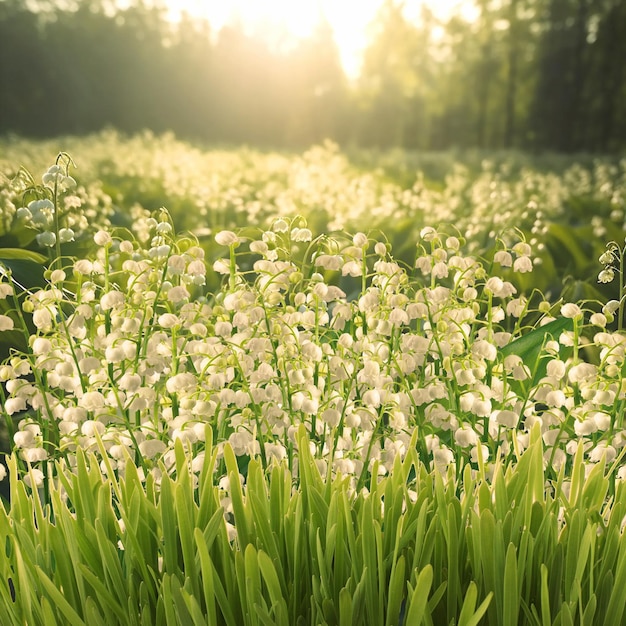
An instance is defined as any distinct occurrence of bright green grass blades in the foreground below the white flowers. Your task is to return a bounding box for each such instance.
[0,428,626,626]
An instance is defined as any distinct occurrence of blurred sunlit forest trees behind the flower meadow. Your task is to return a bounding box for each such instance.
[0,0,626,152]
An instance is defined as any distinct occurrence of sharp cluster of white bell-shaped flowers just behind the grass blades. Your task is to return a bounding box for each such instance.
[0,212,626,498]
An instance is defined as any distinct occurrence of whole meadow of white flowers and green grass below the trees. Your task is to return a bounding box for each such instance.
[0,132,626,626]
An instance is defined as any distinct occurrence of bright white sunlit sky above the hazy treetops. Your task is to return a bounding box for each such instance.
[158,0,473,76]
